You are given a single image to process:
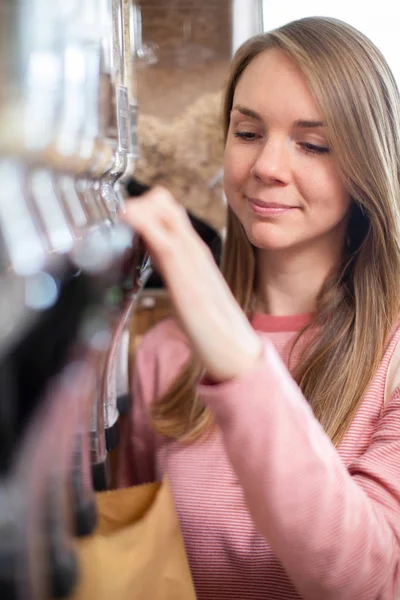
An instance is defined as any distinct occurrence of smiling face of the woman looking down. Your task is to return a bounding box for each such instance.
[225,49,350,254]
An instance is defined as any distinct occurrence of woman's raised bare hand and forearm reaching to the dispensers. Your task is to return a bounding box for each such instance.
[124,187,261,382]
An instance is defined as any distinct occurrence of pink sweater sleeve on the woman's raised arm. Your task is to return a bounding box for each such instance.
[199,340,400,600]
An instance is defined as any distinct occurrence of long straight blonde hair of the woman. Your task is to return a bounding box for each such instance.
[149,17,400,444]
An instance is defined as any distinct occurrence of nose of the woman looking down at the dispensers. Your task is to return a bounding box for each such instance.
[251,136,291,184]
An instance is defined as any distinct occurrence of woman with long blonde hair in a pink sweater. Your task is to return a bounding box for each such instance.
[121,18,400,600]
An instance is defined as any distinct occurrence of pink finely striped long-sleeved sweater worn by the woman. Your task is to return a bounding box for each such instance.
[120,315,400,600]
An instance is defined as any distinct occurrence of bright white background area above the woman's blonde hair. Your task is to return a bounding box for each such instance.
[263,0,400,86]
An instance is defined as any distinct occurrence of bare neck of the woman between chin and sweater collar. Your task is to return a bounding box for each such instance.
[256,245,342,316]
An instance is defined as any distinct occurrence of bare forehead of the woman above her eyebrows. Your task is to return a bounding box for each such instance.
[234,48,321,120]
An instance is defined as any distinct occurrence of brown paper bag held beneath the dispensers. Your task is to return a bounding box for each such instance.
[72,479,196,600]
